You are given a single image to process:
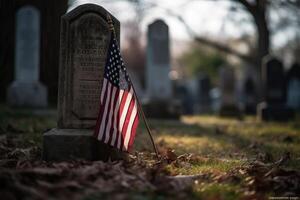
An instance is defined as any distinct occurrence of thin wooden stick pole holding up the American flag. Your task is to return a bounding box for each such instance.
[107,13,159,159]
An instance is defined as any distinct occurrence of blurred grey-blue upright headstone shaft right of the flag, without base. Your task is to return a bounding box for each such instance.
[146,20,172,100]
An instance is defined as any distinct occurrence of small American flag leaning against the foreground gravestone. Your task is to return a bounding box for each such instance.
[94,34,139,151]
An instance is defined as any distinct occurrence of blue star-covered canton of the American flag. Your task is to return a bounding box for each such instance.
[104,38,130,90]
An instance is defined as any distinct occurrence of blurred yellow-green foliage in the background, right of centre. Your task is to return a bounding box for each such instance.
[179,45,226,82]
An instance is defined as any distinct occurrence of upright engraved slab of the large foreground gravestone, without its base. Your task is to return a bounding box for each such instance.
[58,4,120,128]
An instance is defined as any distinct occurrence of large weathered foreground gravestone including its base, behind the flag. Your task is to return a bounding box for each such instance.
[43,4,120,160]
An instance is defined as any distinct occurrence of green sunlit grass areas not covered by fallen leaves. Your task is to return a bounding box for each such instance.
[0,106,300,200]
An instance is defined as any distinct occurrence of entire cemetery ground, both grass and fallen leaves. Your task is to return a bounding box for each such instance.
[0,106,300,200]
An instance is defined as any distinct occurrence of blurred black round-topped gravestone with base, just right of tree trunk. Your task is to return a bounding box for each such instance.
[257,56,294,121]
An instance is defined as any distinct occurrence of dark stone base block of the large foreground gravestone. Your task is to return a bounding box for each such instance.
[43,128,126,161]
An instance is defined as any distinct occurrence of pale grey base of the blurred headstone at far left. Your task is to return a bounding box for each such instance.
[7,81,48,108]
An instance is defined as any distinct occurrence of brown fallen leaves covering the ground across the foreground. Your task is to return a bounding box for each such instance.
[0,135,300,200]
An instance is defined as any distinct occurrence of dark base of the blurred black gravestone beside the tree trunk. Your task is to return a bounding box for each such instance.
[257,102,295,121]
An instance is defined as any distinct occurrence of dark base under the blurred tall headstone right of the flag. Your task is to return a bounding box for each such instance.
[143,100,180,119]
